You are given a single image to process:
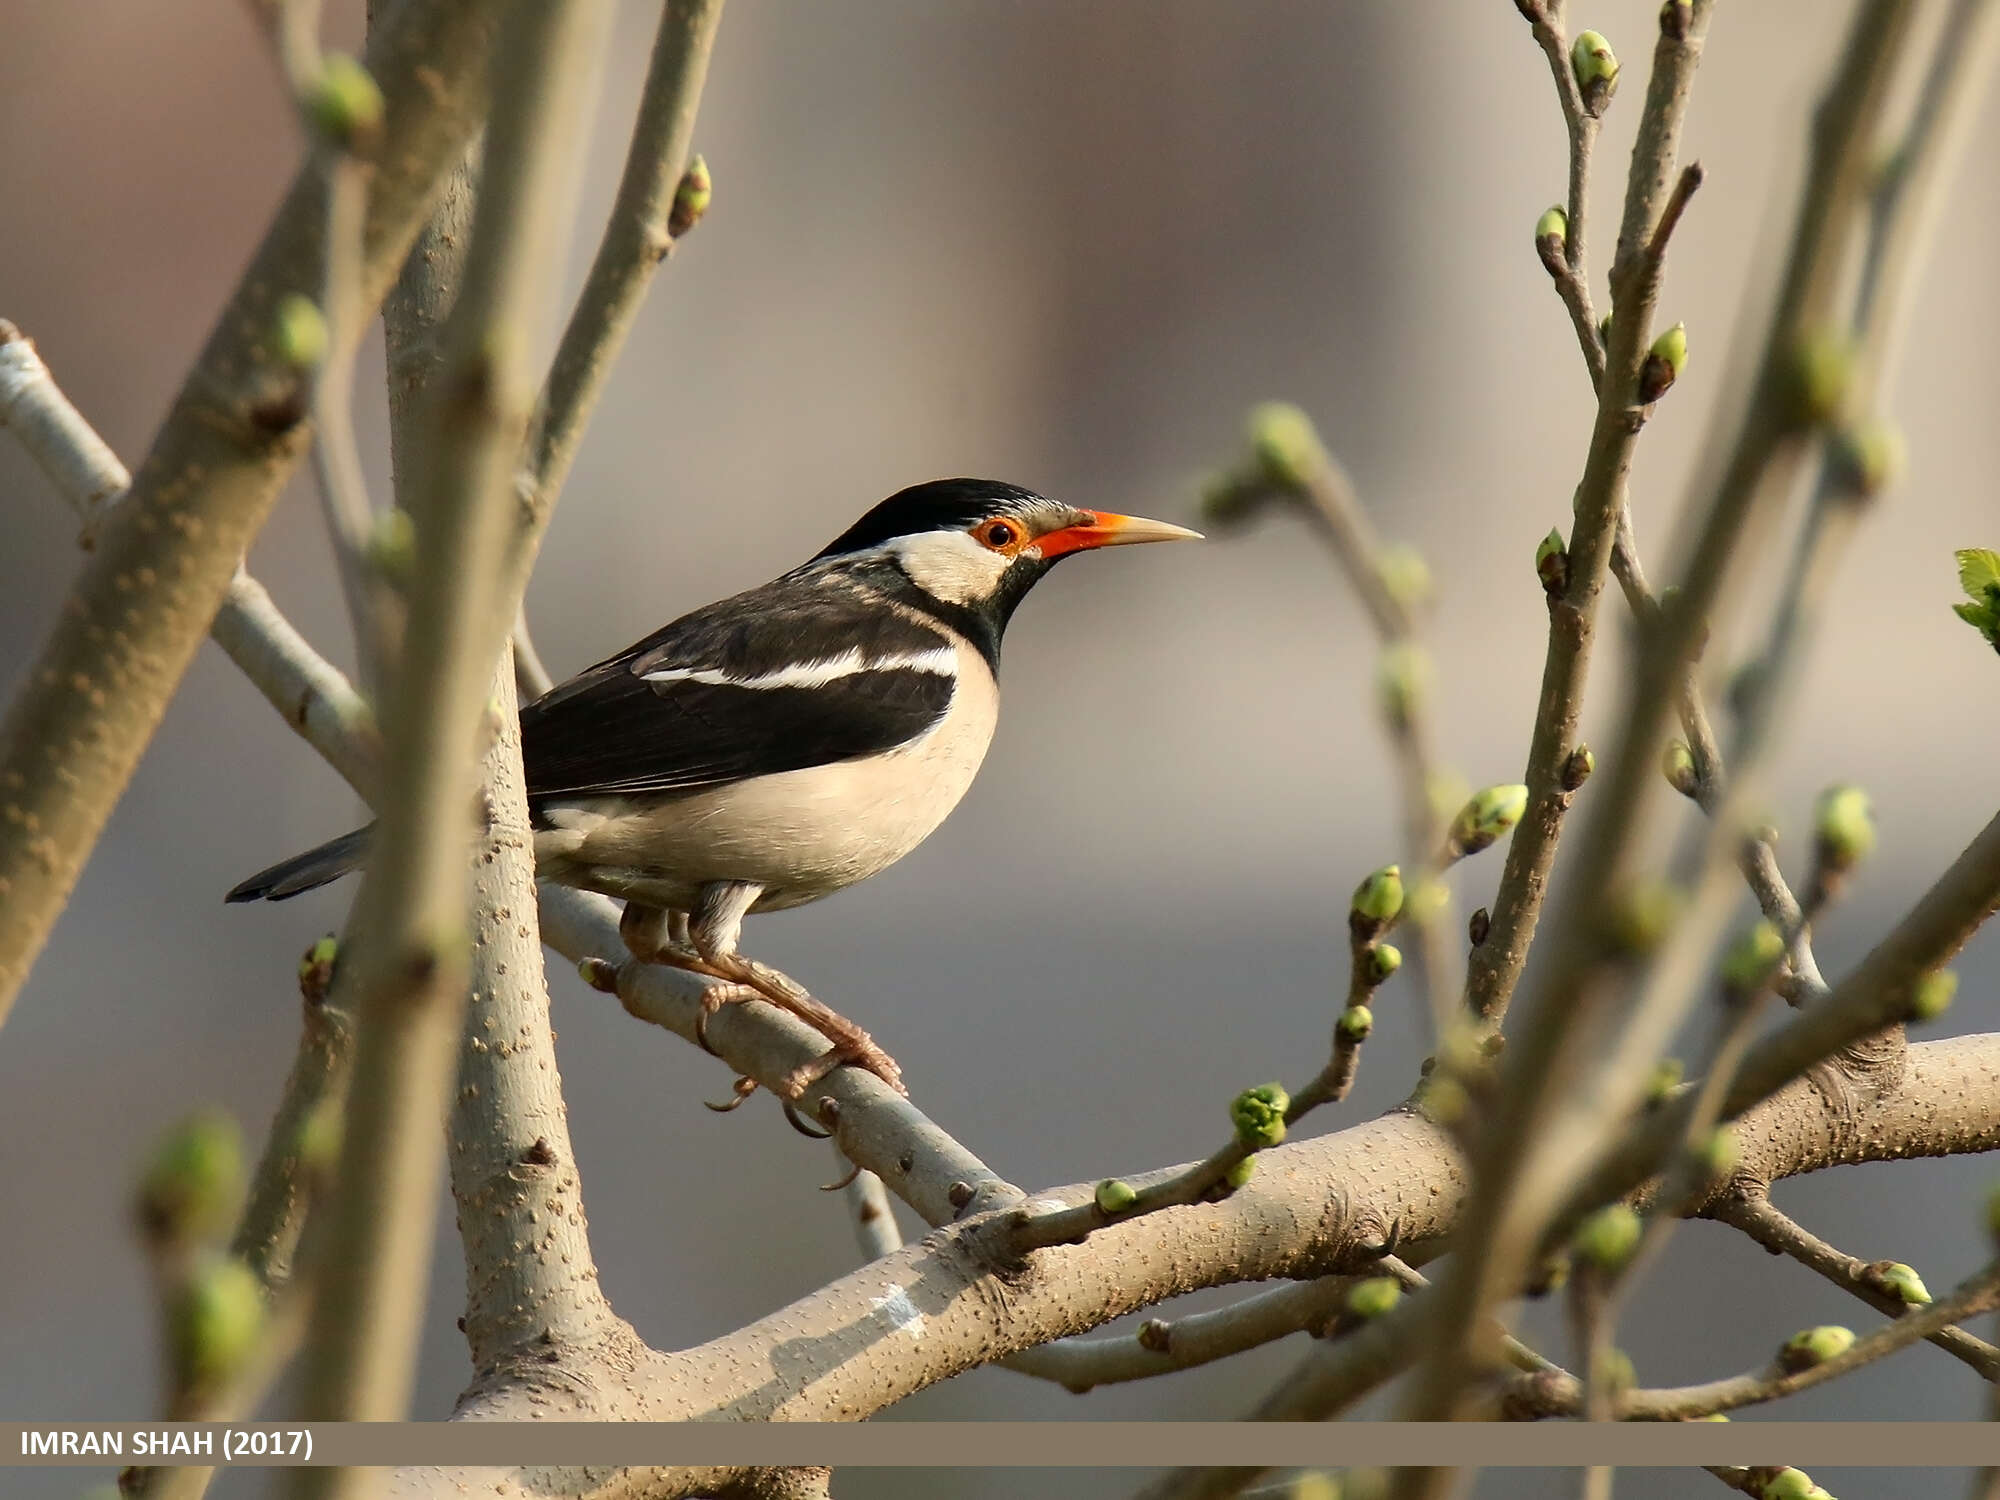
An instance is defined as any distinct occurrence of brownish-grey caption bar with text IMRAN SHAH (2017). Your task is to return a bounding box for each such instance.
[0,1422,2000,1468]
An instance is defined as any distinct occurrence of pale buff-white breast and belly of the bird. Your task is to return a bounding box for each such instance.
[534,648,1000,910]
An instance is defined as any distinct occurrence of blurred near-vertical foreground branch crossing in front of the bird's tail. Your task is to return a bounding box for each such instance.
[302,0,610,1456]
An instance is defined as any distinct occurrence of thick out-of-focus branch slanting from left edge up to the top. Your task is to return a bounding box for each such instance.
[0,0,500,1020]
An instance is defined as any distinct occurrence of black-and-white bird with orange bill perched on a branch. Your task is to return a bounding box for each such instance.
[226,478,1200,1108]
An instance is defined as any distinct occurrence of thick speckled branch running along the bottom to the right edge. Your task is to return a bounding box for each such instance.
[378,1032,2000,1500]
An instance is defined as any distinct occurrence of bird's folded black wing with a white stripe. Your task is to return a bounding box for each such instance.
[520,574,956,804]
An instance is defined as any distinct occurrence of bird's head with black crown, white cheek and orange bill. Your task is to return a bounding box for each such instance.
[812,480,1200,630]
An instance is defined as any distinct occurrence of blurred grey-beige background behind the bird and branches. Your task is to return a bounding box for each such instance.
[0,0,2000,1500]
